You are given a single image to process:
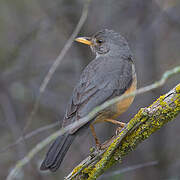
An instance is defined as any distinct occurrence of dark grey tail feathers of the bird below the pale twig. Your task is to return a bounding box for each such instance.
[40,134,76,172]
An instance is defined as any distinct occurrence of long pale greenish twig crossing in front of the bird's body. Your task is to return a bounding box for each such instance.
[7,66,180,180]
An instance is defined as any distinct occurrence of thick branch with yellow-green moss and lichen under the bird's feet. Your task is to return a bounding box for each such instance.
[65,84,180,180]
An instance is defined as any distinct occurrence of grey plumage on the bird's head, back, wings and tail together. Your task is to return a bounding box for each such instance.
[41,30,133,171]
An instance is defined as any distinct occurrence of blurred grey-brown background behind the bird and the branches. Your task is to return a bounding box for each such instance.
[0,0,180,180]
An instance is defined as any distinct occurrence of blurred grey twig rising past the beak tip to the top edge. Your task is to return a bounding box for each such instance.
[23,0,90,132]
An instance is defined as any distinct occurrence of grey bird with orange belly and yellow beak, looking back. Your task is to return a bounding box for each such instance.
[40,29,137,172]
